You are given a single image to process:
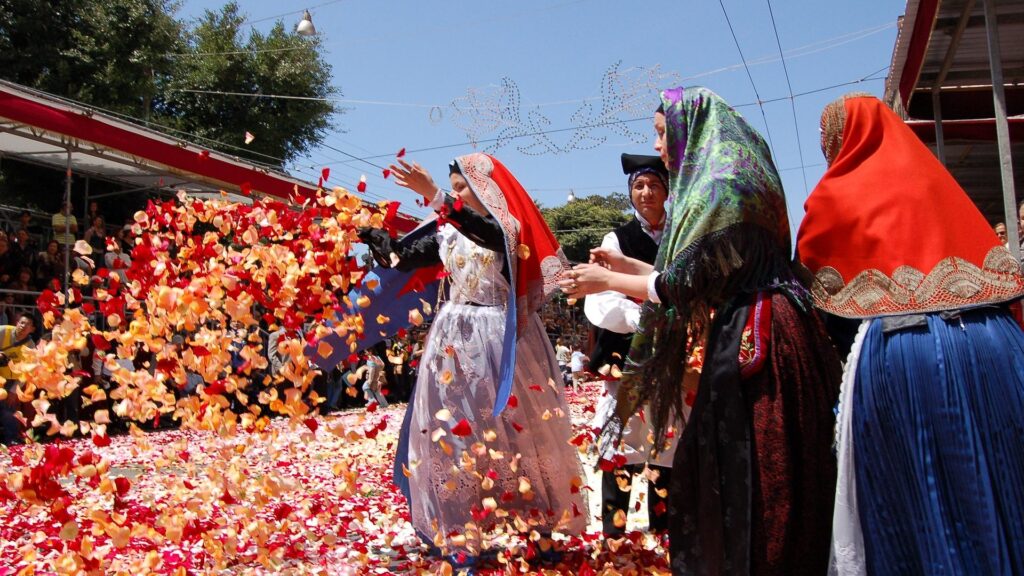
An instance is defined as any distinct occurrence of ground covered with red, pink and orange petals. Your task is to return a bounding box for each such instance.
[0,382,669,576]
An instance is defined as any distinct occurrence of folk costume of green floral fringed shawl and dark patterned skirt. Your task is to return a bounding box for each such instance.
[618,88,840,576]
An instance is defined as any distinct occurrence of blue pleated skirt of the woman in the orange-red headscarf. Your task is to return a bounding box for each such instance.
[852,307,1024,576]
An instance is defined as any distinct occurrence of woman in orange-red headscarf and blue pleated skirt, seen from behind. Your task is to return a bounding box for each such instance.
[798,94,1024,576]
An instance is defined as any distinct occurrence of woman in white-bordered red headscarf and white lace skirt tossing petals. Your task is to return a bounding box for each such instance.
[364,154,588,566]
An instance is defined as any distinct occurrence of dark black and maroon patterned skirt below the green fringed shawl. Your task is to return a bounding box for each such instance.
[670,294,841,576]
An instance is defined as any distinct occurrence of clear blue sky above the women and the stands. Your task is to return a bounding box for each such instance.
[178,0,905,236]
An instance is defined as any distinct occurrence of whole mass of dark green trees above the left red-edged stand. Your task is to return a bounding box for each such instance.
[0,0,336,166]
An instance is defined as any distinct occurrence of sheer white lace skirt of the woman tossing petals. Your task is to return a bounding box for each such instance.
[409,302,588,554]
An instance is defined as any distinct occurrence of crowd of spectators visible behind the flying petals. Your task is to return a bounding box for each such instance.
[0,196,588,443]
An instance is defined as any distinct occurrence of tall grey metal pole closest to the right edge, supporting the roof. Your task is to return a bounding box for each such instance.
[983,0,1021,261]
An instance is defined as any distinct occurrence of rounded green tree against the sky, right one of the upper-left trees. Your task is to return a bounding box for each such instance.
[157,2,337,164]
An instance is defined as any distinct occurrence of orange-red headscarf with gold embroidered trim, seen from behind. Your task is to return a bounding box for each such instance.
[797,96,1024,318]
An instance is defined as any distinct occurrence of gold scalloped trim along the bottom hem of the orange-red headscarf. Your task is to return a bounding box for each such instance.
[811,246,1024,318]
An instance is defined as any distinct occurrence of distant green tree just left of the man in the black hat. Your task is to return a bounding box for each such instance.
[541,193,632,262]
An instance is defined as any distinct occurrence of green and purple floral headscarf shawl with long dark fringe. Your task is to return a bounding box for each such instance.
[618,87,806,446]
